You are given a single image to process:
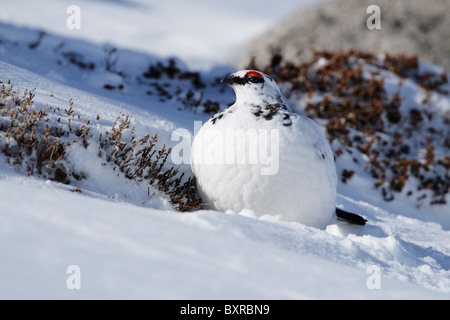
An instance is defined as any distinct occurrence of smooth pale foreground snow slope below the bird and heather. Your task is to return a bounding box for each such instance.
[0,175,445,299]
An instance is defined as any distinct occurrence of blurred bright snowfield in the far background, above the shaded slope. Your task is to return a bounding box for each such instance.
[0,0,317,69]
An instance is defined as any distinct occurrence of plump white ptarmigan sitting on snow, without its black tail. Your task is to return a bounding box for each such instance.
[191,70,337,228]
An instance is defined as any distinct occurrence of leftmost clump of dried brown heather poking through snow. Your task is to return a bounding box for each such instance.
[0,81,85,184]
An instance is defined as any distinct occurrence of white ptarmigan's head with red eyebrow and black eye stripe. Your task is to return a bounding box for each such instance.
[221,70,283,104]
